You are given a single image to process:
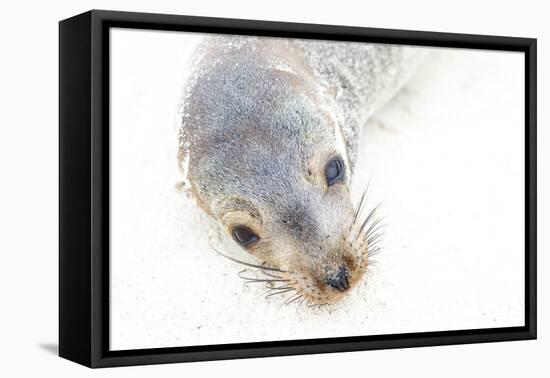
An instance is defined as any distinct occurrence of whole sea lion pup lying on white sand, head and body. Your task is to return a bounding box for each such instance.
[178,36,424,305]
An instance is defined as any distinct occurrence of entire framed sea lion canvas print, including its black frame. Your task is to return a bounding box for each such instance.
[59,10,536,367]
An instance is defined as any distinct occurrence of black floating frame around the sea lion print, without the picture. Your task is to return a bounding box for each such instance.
[59,10,537,368]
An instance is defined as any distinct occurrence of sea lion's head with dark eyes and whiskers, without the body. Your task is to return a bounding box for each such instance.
[179,37,380,304]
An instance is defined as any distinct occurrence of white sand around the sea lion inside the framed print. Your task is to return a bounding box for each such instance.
[111,30,524,350]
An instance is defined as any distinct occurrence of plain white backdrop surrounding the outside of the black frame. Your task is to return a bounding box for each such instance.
[0,0,550,377]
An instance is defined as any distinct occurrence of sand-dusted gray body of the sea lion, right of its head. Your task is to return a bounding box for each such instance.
[296,40,423,165]
